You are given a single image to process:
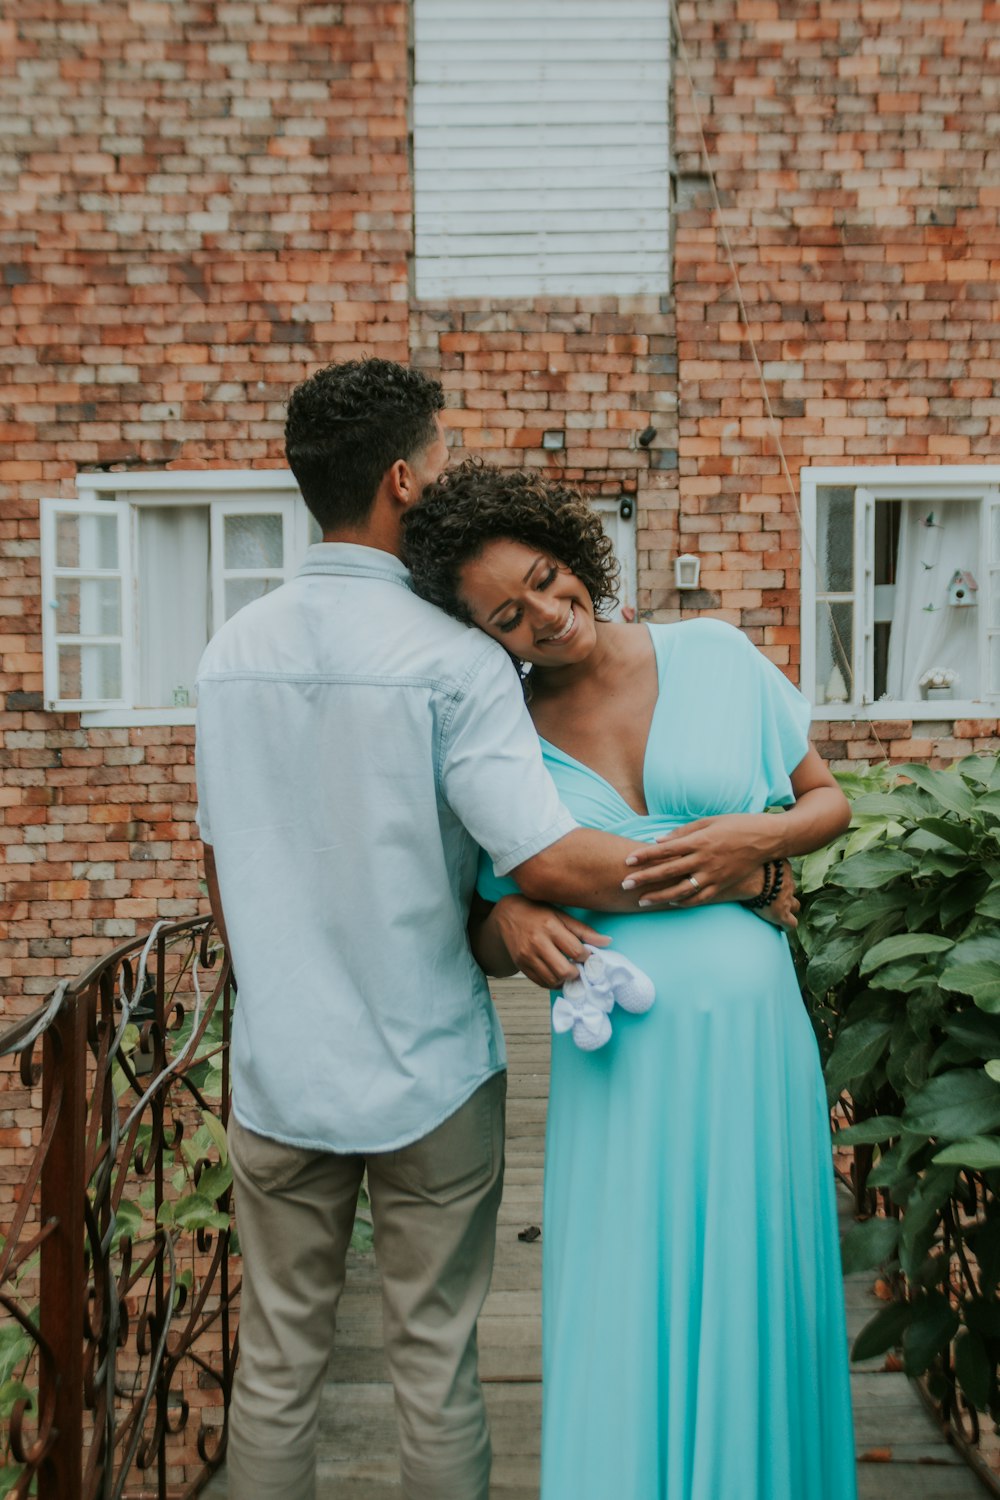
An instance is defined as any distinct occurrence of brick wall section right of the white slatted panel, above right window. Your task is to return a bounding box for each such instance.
[668,0,1000,714]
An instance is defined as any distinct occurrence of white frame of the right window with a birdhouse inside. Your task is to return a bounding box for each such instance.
[799,464,1000,722]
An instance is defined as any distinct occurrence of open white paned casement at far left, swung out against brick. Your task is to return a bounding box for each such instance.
[40,500,132,710]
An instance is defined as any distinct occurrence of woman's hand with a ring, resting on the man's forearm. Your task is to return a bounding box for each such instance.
[628,813,775,906]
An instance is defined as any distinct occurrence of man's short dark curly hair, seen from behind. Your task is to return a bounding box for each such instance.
[285,360,444,531]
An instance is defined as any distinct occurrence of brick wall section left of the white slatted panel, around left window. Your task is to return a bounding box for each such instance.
[0,0,409,1008]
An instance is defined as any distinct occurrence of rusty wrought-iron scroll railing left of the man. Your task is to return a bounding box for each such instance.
[0,918,238,1500]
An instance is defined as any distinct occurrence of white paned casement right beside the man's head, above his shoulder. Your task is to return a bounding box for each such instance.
[211,495,301,632]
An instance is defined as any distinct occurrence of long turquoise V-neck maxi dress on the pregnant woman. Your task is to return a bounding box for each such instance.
[480,620,856,1500]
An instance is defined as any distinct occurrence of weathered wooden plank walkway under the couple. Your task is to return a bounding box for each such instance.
[204,980,985,1500]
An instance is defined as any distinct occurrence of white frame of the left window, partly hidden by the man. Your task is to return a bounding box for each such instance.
[40,468,312,729]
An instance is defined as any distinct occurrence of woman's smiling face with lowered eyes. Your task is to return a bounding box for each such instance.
[459,539,597,668]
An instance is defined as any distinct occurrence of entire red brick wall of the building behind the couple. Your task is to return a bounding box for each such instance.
[0,0,1000,1005]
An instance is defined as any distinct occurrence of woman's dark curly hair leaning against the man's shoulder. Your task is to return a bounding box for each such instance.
[403,459,618,624]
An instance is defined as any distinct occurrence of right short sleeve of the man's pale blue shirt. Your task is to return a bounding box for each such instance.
[439,647,577,876]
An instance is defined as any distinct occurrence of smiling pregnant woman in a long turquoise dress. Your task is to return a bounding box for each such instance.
[406,464,855,1500]
